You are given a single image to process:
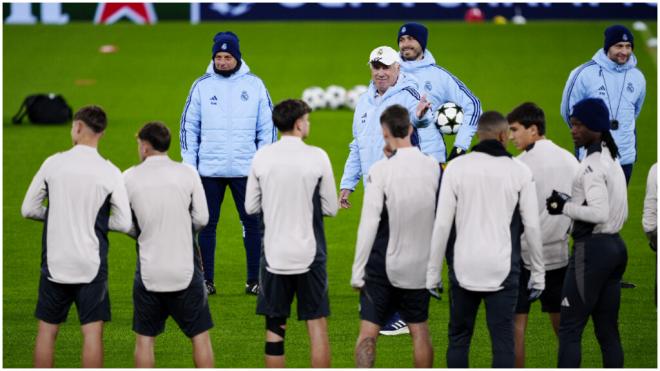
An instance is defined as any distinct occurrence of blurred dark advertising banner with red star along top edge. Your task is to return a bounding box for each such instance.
[3,2,657,24]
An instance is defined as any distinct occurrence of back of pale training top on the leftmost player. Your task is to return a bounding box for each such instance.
[37,145,121,283]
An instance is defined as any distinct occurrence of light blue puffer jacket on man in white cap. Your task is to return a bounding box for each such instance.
[340,73,438,190]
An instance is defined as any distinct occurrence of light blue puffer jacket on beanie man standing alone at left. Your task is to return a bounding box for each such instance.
[180,62,277,177]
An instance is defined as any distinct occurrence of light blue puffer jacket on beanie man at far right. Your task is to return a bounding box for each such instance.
[561,48,646,165]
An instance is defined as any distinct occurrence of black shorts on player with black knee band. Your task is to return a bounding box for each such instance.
[257,263,330,321]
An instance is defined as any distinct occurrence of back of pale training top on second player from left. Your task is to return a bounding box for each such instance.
[124,156,208,292]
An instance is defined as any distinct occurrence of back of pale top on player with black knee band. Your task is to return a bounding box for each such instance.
[246,136,337,274]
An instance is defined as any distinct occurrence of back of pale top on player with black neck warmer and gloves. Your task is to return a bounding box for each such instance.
[439,151,532,291]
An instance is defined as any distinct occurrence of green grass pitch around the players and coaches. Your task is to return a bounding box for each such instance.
[3,21,657,368]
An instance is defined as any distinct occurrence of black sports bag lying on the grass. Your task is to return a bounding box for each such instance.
[11,93,72,124]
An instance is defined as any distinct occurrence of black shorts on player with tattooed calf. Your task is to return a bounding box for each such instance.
[360,281,431,327]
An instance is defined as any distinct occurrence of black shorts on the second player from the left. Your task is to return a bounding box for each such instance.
[133,274,213,338]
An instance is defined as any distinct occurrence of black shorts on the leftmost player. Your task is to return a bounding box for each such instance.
[34,274,110,325]
